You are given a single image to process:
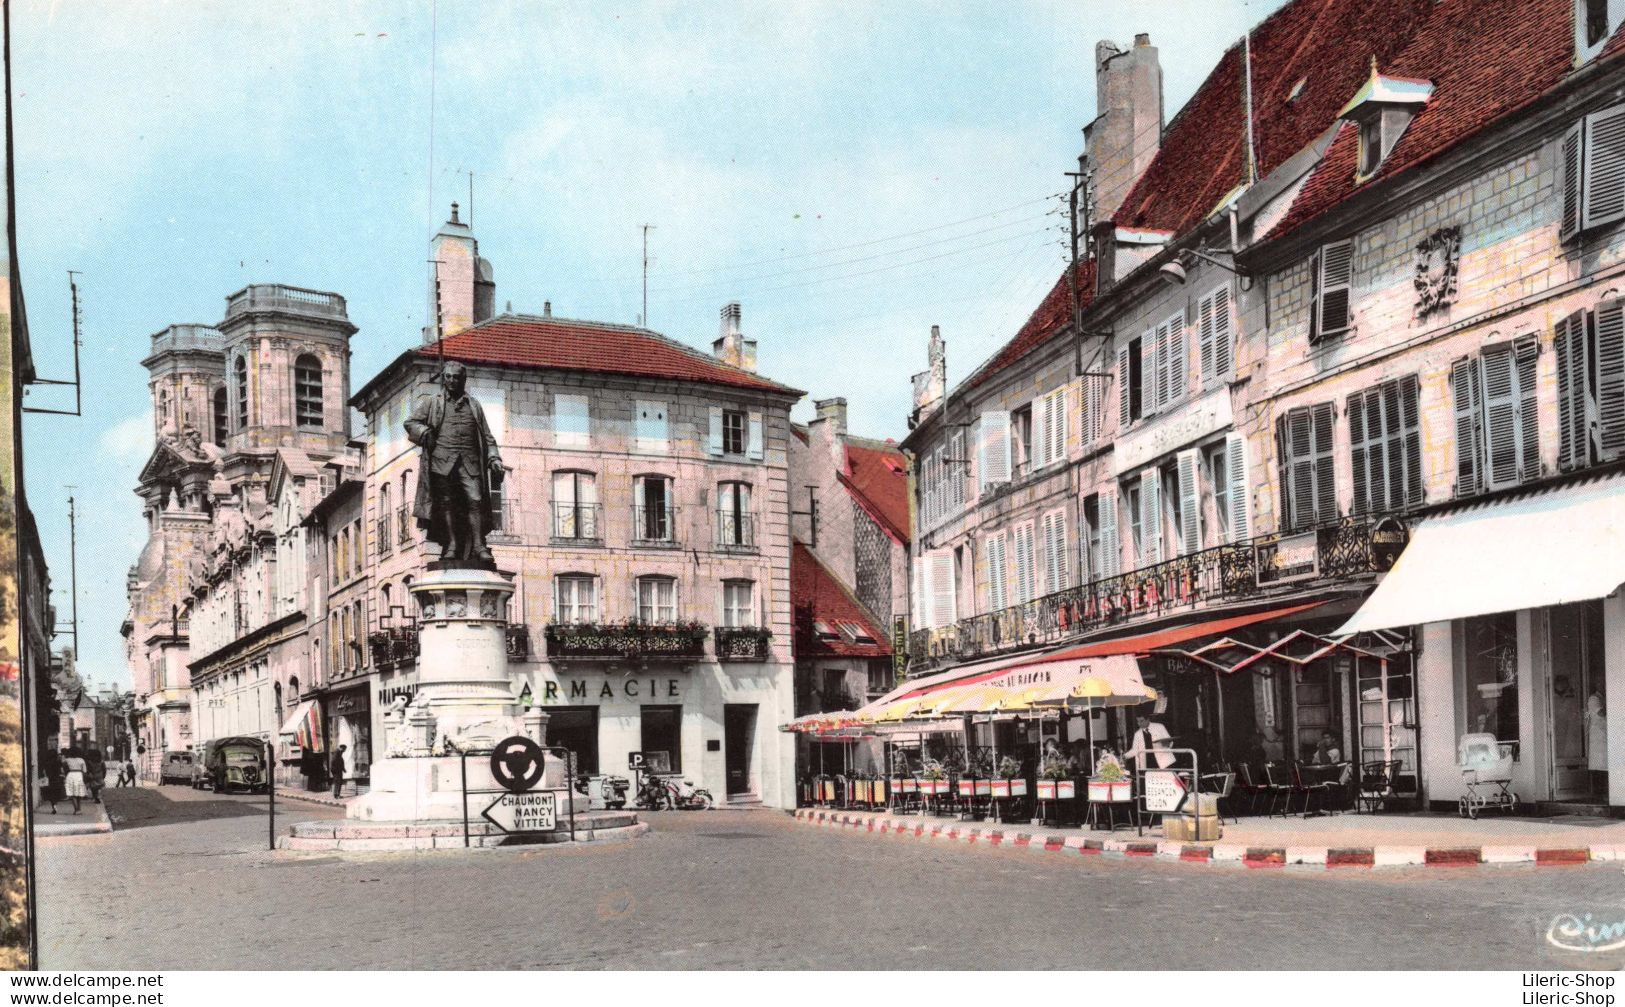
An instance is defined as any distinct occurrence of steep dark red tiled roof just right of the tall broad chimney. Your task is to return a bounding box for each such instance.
[1113,0,1430,234]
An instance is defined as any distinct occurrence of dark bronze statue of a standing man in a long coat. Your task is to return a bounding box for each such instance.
[406,362,504,567]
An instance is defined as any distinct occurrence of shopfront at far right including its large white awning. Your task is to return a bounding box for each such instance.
[1339,473,1625,810]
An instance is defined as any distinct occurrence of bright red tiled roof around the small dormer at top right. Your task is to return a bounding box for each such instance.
[1271,0,1625,237]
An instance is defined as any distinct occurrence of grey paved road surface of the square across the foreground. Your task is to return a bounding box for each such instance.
[39,788,1625,970]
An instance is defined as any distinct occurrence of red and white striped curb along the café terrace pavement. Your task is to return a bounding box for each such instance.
[795,807,1625,867]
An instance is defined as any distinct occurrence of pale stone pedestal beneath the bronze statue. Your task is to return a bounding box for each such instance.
[349,568,569,822]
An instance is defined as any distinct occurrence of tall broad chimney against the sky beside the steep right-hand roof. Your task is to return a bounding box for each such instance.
[1084,34,1164,224]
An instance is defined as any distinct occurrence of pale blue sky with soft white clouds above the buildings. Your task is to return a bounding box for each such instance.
[11,0,1279,684]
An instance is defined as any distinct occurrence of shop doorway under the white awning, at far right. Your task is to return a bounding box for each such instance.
[1545,601,1607,801]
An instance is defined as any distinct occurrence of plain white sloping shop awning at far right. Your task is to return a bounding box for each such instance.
[1336,473,1625,637]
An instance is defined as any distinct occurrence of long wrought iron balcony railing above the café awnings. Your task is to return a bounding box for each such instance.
[908,515,1402,671]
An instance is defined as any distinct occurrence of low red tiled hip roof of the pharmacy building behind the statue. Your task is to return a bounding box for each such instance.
[416,315,801,395]
